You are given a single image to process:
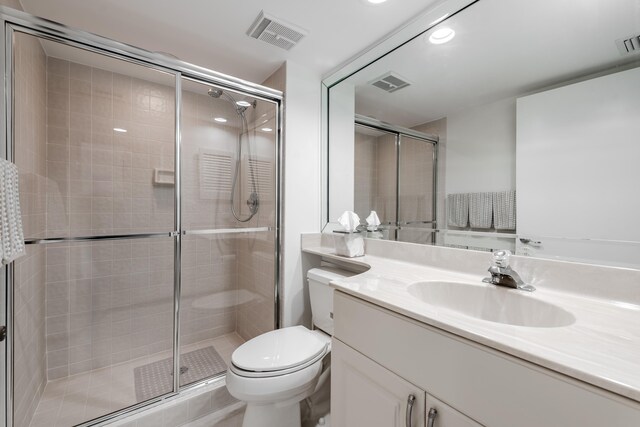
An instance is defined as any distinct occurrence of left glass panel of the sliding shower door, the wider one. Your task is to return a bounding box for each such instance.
[11,31,177,427]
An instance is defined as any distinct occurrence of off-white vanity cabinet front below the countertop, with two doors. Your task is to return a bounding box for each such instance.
[331,290,640,427]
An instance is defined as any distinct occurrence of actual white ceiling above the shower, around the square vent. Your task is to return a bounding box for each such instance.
[20,0,437,83]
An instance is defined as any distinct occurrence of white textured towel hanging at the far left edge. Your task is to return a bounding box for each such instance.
[0,159,24,264]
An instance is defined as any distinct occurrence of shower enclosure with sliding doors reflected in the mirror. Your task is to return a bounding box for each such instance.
[354,115,438,244]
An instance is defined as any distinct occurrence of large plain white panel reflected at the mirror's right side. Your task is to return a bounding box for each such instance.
[517,68,640,266]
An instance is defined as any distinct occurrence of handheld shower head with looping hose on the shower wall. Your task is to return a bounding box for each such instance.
[207,88,260,222]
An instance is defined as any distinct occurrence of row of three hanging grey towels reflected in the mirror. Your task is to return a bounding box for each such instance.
[447,190,516,230]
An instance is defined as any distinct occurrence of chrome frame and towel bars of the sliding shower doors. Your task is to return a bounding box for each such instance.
[0,6,284,427]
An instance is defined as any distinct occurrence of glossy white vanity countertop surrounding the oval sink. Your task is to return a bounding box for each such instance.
[303,246,640,402]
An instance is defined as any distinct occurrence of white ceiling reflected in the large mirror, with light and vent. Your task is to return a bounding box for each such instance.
[348,0,640,127]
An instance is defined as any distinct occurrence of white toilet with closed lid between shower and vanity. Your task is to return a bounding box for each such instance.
[227,267,354,427]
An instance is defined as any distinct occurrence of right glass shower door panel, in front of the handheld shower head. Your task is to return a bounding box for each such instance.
[180,78,277,392]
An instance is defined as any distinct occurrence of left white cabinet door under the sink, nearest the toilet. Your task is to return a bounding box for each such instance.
[331,339,426,427]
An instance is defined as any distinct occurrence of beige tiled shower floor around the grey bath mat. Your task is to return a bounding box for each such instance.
[30,333,244,427]
